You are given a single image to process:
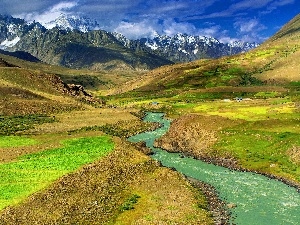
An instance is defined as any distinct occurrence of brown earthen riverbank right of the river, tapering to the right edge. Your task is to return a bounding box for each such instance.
[154,114,300,192]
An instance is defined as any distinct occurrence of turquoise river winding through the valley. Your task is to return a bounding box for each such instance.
[128,113,300,225]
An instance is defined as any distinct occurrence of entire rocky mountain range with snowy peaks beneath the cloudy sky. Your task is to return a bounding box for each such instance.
[0,14,258,70]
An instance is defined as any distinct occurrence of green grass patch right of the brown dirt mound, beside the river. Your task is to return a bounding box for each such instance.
[214,128,300,182]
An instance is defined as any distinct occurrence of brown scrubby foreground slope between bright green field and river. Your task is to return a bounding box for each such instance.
[0,138,213,225]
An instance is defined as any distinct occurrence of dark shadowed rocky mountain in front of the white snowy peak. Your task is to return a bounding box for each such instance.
[11,27,171,70]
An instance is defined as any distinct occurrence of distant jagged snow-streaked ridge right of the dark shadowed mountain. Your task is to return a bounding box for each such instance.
[114,33,258,62]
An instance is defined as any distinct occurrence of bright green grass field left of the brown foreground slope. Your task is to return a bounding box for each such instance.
[0,136,114,209]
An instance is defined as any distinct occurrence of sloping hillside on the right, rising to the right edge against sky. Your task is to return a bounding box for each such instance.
[109,15,300,94]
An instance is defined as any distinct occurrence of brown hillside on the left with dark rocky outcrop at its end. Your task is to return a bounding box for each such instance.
[0,54,100,115]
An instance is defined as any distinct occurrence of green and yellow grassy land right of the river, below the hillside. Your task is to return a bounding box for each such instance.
[102,78,300,185]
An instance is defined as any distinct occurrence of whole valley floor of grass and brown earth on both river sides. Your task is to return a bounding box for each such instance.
[0,89,300,224]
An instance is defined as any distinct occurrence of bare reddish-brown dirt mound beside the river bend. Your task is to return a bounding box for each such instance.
[154,114,240,169]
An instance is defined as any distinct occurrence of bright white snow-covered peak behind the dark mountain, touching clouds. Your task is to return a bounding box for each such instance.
[43,14,99,33]
